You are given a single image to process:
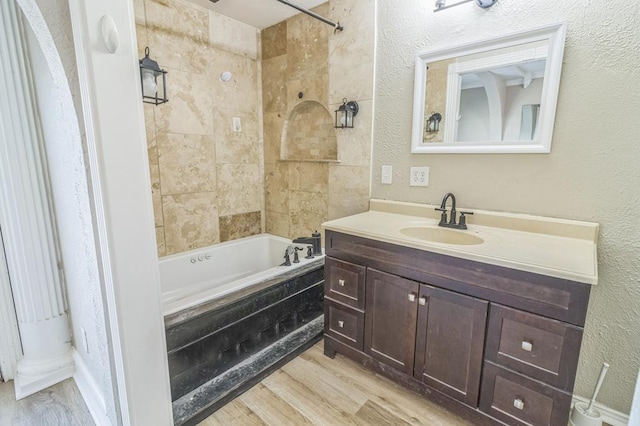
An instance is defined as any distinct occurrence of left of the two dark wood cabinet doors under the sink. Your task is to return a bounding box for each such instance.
[364,269,419,375]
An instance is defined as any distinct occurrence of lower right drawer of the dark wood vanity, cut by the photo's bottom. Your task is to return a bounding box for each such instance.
[480,362,571,426]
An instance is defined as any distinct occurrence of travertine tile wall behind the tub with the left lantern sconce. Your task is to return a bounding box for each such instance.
[134,0,264,256]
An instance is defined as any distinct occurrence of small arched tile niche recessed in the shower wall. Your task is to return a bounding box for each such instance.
[280,100,338,162]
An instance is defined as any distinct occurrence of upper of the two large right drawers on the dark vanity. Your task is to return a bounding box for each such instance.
[485,304,582,392]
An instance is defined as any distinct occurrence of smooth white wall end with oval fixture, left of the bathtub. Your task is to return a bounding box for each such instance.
[69,0,172,426]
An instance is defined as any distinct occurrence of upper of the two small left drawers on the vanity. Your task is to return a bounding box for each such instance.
[324,257,366,310]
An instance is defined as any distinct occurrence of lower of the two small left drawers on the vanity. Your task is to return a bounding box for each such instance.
[324,299,364,351]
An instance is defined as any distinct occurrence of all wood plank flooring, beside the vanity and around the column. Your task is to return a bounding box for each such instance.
[0,342,476,426]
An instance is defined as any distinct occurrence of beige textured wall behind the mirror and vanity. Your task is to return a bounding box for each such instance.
[372,0,640,412]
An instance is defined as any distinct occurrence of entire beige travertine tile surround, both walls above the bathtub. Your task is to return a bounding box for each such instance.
[134,0,374,256]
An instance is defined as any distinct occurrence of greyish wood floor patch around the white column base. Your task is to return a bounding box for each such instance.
[0,379,94,426]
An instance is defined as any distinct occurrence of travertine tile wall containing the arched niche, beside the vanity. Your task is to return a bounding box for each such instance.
[262,0,375,238]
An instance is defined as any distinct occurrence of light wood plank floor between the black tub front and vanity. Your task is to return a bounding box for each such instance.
[200,342,469,426]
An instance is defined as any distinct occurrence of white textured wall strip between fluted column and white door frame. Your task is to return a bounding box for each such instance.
[21,0,119,424]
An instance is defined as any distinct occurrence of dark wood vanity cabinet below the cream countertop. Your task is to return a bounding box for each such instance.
[325,231,590,426]
